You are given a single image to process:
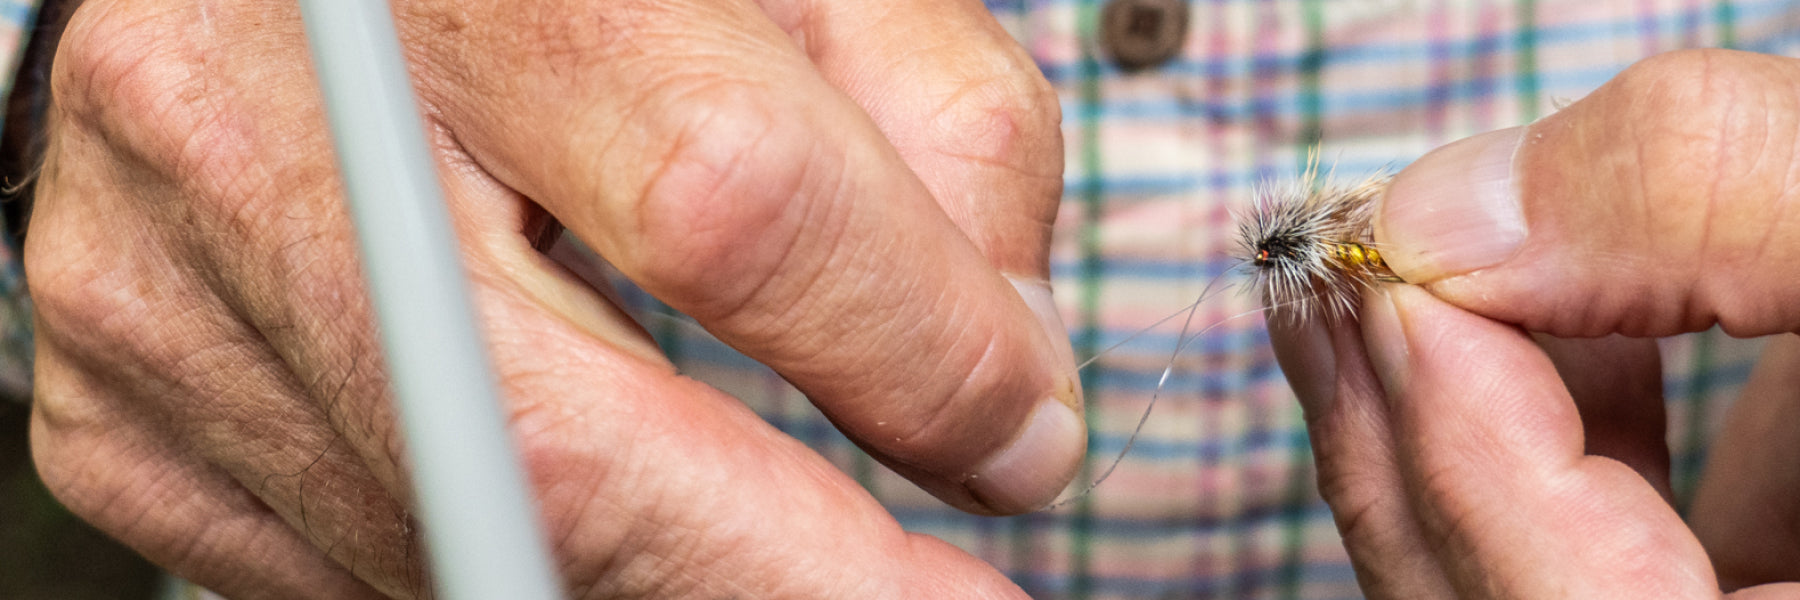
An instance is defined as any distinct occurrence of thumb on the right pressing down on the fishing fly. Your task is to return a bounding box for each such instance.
[1375,50,1800,337]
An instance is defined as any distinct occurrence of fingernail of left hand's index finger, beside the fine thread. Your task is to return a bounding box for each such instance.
[963,398,1087,515]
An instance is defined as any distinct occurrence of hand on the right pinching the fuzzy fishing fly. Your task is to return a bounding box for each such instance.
[1274,50,1800,598]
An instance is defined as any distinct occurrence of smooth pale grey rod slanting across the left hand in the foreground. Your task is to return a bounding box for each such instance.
[301,0,562,600]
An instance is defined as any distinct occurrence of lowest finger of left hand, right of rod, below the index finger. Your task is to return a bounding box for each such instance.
[479,276,1024,598]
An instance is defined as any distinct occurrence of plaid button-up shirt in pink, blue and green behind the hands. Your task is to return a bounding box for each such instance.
[632,0,1800,598]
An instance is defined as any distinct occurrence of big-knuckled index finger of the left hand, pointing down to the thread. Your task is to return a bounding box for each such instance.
[403,0,1084,514]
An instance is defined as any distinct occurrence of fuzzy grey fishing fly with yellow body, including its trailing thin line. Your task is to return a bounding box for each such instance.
[1044,150,1402,510]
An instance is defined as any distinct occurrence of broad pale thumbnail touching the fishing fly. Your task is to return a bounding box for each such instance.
[1375,126,1526,283]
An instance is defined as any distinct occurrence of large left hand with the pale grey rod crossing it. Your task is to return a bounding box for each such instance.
[25,0,1085,598]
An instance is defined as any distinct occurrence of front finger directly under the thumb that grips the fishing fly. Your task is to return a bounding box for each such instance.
[1363,286,1719,598]
